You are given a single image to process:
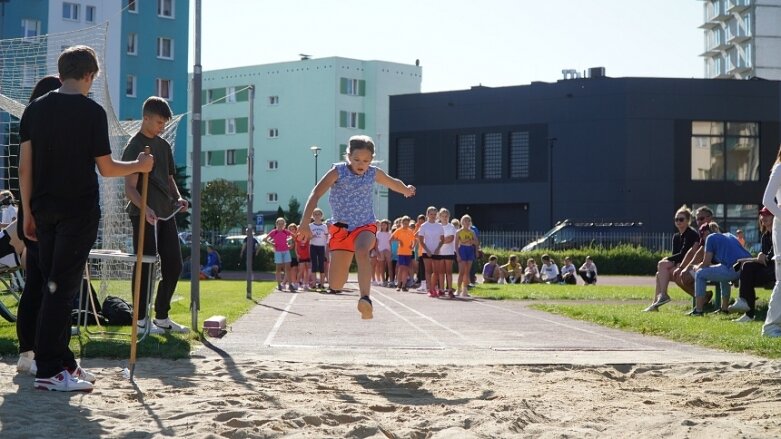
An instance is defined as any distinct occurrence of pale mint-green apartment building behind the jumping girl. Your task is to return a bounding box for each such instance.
[187,57,421,224]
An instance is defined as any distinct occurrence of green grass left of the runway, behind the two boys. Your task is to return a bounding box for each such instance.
[0,280,276,359]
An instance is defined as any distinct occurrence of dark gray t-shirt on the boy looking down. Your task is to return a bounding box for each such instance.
[122,132,179,218]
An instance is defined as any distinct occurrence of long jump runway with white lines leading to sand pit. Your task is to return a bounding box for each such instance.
[194,283,760,365]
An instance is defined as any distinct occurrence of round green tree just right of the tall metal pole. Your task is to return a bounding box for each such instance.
[201,178,246,233]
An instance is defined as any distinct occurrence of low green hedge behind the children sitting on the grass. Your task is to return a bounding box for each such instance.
[479,245,669,276]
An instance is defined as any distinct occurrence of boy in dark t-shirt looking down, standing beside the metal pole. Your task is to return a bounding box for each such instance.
[122,96,189,334]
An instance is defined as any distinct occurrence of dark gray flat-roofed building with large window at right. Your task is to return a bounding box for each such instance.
[389,77,781,239]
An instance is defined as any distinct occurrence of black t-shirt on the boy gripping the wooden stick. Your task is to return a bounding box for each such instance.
[19,92,111,216]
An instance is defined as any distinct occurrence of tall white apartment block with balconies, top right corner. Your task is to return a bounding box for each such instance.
[700,0,781,80]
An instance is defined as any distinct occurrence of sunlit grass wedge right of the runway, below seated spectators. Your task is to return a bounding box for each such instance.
[532,301,781,358]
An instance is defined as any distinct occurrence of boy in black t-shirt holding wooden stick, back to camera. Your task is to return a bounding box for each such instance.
[19,46,153,392]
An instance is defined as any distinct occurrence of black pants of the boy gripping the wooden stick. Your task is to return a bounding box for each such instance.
[35,206,100,378]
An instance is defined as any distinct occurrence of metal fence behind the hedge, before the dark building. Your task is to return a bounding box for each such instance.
[480,230,672,252]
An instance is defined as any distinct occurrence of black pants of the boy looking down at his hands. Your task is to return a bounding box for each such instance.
[130,215,181,320]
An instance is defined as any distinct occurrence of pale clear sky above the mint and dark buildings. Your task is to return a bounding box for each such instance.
[190,0,703,92]
